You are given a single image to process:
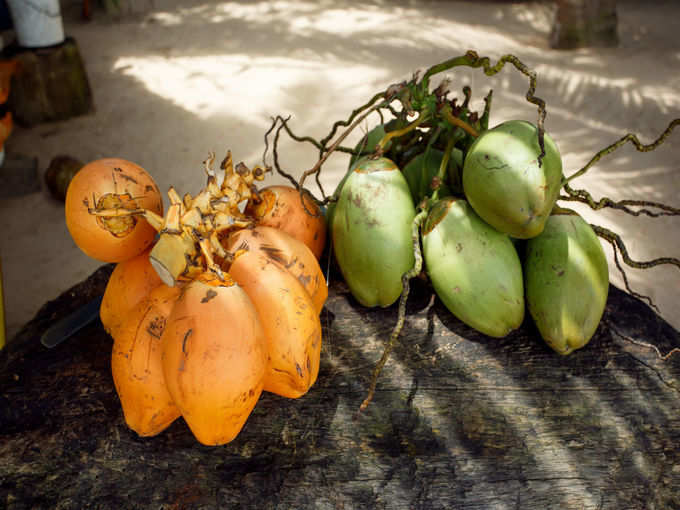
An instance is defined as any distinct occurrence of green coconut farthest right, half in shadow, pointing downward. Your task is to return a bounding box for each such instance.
[524,213,609,354]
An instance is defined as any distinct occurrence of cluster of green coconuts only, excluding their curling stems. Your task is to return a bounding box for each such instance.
[328,115,609,354]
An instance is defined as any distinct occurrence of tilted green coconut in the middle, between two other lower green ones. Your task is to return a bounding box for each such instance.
[423,197,524,338]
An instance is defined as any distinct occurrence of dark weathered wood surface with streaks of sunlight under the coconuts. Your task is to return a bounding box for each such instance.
[0,266,680,510]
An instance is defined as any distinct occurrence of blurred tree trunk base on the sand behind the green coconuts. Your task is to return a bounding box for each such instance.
[550,0,619,49]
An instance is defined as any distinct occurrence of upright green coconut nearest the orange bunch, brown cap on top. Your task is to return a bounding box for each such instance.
[330,158,415,307]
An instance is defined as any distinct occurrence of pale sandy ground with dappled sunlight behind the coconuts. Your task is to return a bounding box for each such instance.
[0,0,680,338]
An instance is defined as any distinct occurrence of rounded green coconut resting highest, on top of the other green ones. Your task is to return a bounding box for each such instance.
[463,120,562,239]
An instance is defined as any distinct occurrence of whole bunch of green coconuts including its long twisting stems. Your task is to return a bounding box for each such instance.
[265,51,680,370]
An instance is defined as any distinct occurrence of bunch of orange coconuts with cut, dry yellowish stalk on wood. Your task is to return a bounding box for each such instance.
[65,153,328,445]
